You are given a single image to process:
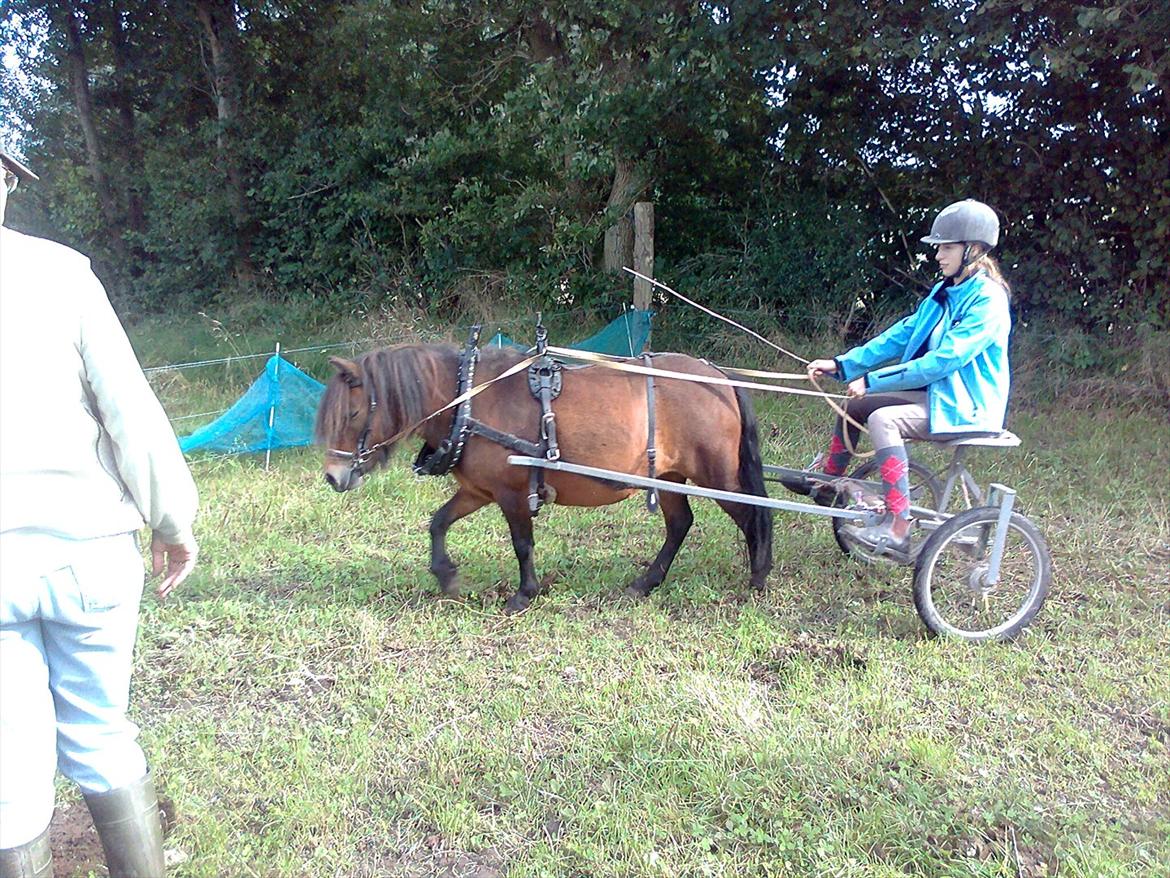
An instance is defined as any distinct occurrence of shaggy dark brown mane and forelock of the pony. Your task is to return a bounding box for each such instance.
[314,344,519,460]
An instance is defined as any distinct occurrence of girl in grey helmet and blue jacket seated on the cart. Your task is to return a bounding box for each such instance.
[783,199,1011,555]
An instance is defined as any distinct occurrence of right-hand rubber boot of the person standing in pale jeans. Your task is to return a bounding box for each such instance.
[85,774,166,878]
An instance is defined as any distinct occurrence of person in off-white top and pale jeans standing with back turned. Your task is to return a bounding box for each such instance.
[0,151,198,878]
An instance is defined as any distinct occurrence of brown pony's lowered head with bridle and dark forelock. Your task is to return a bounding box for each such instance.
[316,345,434,491]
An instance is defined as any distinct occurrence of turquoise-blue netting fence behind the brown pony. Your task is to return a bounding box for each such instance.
[171,310,653,454]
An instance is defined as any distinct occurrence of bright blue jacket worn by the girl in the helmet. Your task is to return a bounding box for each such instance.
[837,273,1012,433]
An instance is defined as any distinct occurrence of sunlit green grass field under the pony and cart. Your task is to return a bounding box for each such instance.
[52,313,1170,878]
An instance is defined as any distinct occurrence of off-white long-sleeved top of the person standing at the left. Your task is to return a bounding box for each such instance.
[0,227,198,571]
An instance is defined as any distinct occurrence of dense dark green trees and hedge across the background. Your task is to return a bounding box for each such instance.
[0,0,1170,330]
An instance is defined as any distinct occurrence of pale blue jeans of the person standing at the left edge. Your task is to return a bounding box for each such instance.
[0,534,146,849]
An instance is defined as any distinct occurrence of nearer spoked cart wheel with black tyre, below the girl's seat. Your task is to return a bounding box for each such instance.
[914,506,1052,640]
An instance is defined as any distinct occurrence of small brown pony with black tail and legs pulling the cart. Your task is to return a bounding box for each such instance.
[316,344,772,612]
